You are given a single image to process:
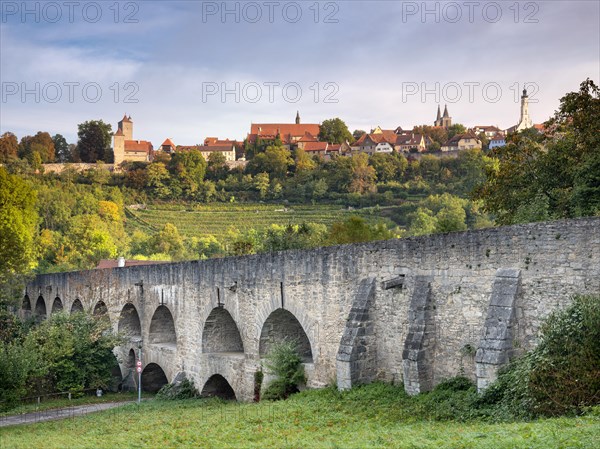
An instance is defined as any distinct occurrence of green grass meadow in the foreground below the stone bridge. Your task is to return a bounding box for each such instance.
[0,384,600,449]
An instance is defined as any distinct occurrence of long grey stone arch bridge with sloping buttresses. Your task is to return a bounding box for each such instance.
[22,218,600,400]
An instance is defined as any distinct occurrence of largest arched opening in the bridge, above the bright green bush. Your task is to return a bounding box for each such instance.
[259,309,313,363]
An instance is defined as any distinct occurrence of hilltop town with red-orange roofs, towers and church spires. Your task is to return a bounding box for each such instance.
[108,90,544,168]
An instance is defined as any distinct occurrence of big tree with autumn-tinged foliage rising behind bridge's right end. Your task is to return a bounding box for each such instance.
[475,79,600,224]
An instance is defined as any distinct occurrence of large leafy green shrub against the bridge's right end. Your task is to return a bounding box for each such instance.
[480,295,600,417]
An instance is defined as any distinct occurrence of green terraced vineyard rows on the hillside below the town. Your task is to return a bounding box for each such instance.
[127,203,390,237]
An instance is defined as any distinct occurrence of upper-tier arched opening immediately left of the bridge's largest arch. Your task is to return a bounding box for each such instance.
[202,307,244,353]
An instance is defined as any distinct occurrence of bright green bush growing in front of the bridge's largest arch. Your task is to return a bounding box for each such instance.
[263,340,306,400]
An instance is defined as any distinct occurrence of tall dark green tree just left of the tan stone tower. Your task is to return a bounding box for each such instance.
[77,120,113,162]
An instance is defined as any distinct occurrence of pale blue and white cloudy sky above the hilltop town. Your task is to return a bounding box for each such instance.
[0,1,600,147]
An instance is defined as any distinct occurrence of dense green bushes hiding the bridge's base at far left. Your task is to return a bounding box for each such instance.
[0,313,120,409]
